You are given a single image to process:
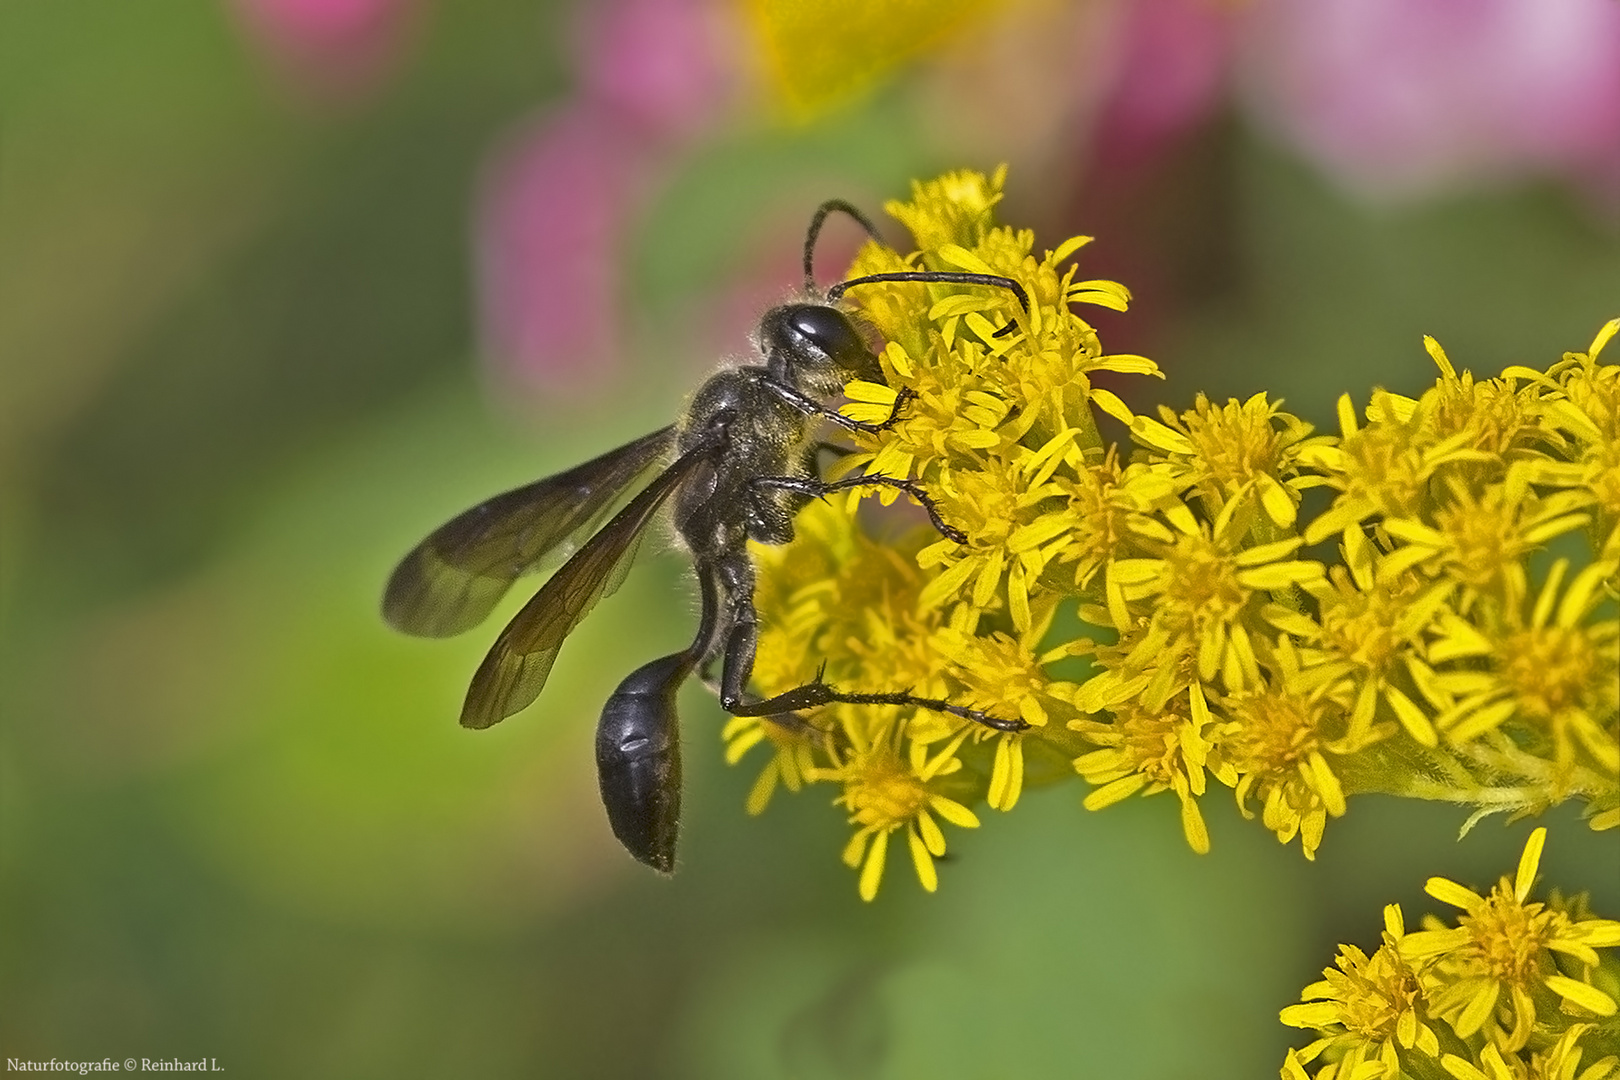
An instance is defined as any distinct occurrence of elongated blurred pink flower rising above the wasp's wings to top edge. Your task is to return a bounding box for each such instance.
[475,0,735,392]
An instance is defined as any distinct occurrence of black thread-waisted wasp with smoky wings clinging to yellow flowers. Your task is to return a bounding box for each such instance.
[382,199,1029,873]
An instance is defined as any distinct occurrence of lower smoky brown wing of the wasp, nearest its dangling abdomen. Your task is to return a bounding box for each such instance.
[462,447,711,727]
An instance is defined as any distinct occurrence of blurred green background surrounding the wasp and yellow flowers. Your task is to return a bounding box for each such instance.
[0,0,1620,1078]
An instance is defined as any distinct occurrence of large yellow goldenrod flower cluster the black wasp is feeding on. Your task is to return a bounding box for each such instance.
[726,170,1620,899]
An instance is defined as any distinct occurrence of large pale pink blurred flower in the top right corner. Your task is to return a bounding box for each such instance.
[1243,0,1620,198]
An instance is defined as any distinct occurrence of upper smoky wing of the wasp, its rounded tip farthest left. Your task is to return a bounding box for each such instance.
[382,427,676,638]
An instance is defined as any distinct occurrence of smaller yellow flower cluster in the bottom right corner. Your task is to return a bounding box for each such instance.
[1281,829,1620,1080]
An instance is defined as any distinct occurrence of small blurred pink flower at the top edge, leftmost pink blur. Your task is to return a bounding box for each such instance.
[232,0,416,97]
